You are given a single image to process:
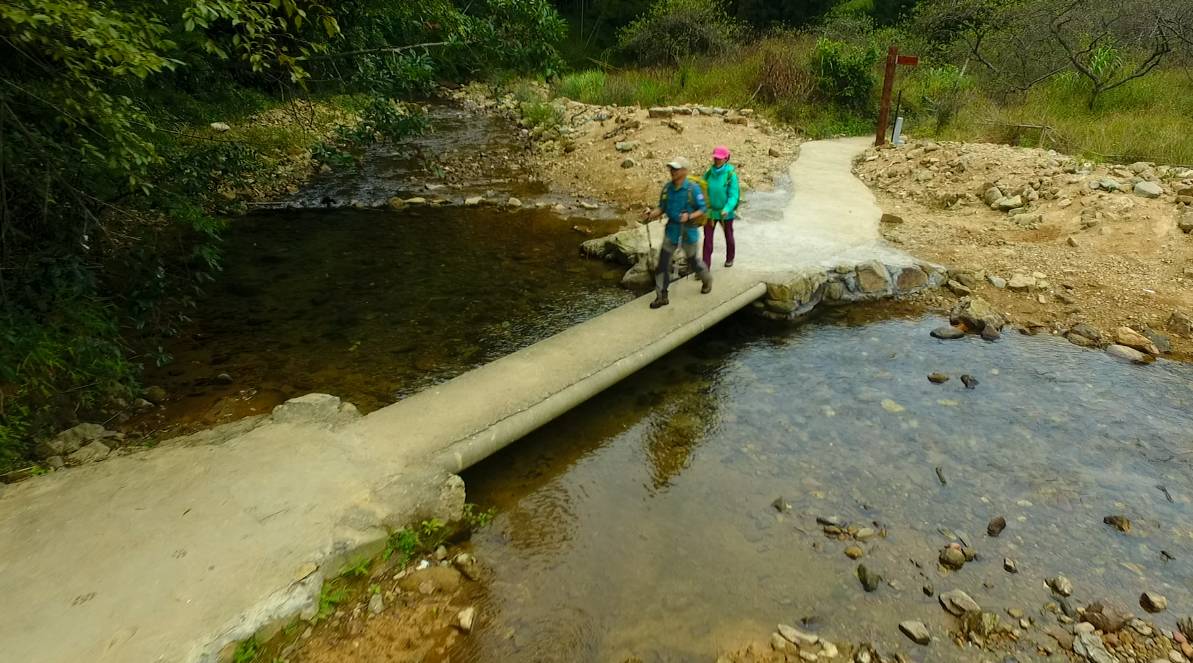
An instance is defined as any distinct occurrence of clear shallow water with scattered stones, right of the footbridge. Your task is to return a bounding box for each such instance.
[458,310,1193,662]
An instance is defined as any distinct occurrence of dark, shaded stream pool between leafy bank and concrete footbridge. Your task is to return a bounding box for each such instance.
[137,206,631,438]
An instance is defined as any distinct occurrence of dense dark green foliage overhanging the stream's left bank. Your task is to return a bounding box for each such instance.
[0,0,565,469]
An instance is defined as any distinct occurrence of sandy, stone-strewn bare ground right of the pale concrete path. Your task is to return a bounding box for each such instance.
[855,137,1193,360]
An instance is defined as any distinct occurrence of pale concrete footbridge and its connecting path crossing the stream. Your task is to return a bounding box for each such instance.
[0,140,941,663]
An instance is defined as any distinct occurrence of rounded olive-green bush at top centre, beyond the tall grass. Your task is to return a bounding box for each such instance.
[618,0,746,64]
